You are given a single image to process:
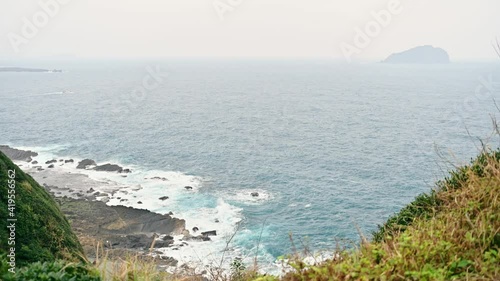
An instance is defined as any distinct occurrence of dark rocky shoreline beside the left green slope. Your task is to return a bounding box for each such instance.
[0,145,217,267]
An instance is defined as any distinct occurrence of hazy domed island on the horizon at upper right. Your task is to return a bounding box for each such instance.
[382,45,450,64]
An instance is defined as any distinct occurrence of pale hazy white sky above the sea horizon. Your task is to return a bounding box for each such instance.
[0,0,500,61]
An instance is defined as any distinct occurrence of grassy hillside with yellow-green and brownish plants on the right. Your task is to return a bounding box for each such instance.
[270,151,500,280]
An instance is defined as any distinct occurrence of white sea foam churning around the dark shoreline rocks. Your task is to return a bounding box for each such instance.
[13,146,272,269]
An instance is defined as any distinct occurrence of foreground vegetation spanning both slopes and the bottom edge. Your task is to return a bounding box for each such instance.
[0,143,500,281]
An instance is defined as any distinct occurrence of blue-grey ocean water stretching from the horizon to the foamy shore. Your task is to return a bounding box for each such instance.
[0,60,500,270]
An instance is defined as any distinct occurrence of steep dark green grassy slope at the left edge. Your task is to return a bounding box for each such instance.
[0,152,83,268]
